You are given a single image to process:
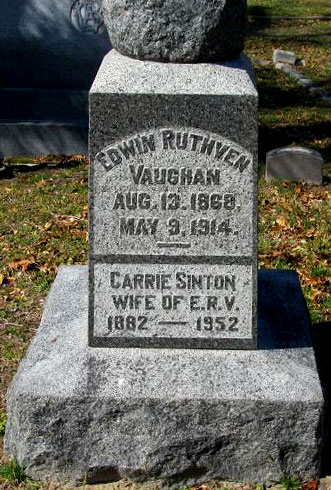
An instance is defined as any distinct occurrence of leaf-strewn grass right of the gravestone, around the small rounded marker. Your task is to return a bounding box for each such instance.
[245,0,331,330]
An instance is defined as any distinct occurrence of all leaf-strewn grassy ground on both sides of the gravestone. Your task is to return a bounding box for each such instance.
[0,0,331,490]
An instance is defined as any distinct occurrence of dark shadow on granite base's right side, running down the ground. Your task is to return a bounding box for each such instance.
[258,269,331,476]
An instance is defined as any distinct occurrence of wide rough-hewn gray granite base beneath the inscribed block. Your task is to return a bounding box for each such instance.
[5,266,324,485]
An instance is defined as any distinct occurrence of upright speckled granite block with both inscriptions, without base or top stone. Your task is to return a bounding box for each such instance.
[89,51,257,348]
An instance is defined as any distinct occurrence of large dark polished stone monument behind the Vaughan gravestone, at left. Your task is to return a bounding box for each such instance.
[0,0,111,158]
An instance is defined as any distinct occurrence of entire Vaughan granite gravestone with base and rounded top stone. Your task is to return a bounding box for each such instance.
[5,0,324,485]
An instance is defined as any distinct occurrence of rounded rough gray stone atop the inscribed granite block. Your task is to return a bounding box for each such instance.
[103,0,247,62]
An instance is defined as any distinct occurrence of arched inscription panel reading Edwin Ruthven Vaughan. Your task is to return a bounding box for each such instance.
[92,129,253,256]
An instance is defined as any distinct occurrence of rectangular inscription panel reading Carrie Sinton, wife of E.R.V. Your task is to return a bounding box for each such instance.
[94,264,252,339]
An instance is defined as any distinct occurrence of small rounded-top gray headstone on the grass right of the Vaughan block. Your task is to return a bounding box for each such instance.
[265,147,324,184]
